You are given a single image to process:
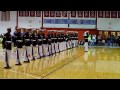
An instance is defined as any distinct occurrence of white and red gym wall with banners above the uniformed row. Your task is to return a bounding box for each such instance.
[0,11,120,40]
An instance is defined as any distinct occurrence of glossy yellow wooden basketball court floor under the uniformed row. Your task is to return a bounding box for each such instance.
[0,46,120,79]
